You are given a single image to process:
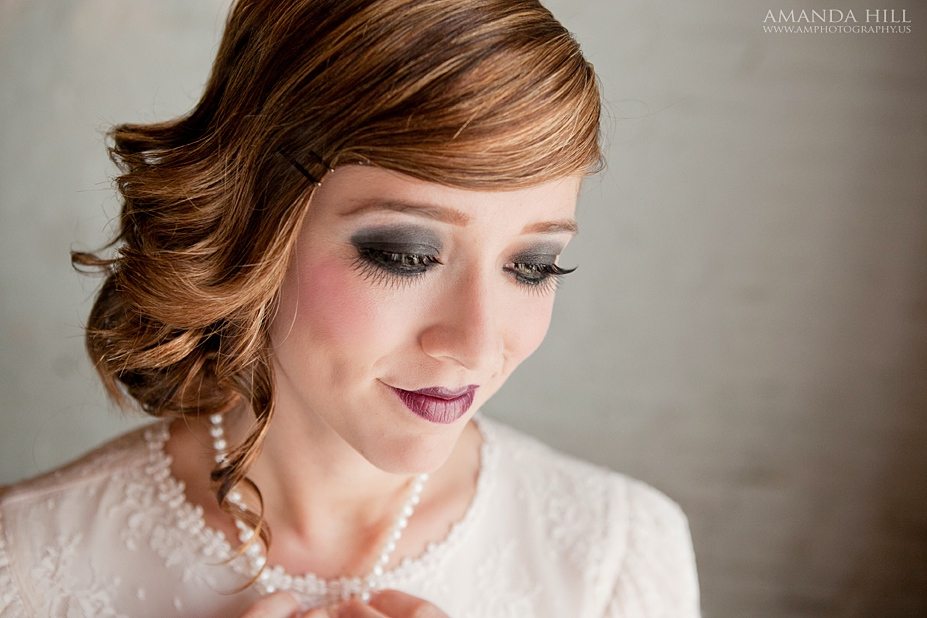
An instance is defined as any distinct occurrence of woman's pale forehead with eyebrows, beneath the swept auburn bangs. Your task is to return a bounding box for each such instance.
[313,165,581,234]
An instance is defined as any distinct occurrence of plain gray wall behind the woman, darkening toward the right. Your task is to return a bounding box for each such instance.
[0,0,927,617]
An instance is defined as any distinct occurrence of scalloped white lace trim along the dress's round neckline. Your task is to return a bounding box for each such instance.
[144,412,496,594]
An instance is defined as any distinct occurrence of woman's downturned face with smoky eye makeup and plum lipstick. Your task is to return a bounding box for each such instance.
[271,165,580,473]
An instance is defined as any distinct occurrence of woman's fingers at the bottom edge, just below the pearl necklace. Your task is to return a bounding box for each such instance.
[241,590,450,618]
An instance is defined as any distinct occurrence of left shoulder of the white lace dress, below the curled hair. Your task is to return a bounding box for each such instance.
[0,422,252,617]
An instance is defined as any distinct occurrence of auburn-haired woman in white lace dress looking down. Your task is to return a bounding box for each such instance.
[0,0,698,618]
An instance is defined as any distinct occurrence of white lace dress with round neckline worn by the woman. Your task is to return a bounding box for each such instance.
[0,415,699,618]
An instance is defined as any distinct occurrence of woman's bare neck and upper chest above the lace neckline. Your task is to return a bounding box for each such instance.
[168,390,482,577]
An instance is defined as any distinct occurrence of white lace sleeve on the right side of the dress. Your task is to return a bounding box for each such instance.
[605,481,701,618]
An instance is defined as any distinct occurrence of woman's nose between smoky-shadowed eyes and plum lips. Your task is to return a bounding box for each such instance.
[419,268,505,376]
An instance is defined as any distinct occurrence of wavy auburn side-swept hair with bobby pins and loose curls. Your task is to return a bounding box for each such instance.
[72,0,601,560]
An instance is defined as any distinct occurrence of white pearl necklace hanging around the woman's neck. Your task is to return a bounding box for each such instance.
[209,414,428,604]
